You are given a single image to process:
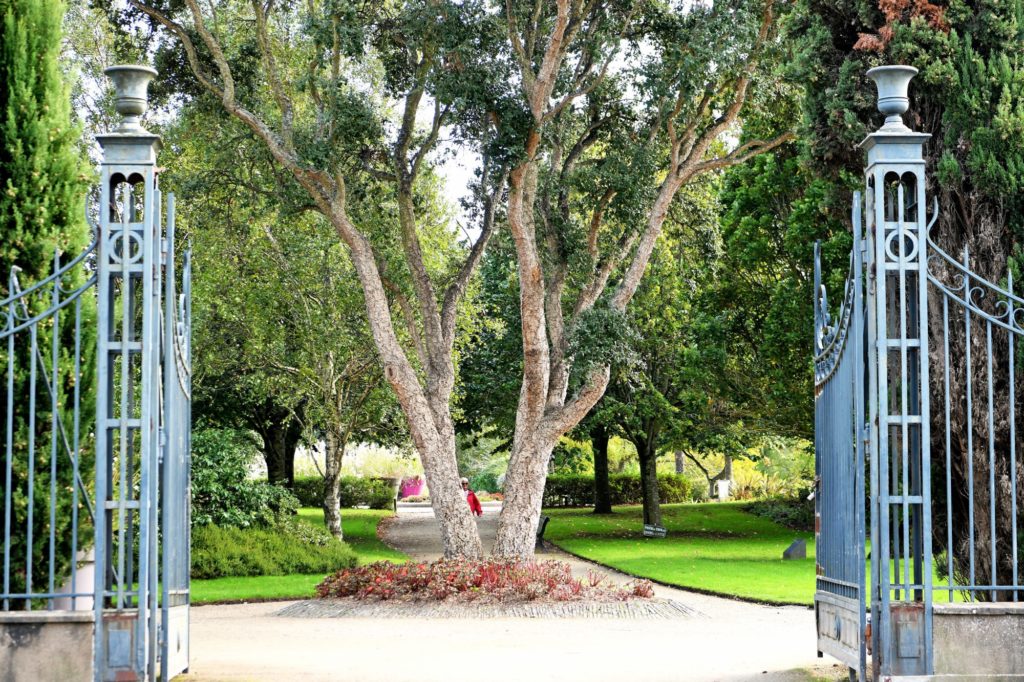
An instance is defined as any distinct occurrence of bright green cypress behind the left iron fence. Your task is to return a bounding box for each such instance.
[0,0,95,608]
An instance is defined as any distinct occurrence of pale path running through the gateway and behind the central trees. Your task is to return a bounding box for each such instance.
[178,507,844,682]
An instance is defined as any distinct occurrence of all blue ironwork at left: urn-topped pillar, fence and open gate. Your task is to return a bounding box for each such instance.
[0,67,190,682]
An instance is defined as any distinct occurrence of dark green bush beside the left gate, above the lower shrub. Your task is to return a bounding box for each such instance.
[191,428,299,528]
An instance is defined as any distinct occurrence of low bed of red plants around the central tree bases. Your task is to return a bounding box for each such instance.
[316,559,654,602]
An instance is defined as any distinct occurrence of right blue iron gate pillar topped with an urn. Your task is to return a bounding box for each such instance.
[861,62,933,675]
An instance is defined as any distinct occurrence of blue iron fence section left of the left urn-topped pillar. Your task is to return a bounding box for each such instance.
[0,236,96,610]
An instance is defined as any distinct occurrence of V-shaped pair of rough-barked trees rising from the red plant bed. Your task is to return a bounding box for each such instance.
[133,0,788,556]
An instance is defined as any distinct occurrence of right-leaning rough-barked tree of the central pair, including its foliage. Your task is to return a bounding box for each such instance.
[495,0,792,557]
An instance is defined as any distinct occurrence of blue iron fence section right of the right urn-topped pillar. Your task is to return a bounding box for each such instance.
[928,239,1024,601]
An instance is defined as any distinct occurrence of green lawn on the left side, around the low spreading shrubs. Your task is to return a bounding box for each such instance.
[191,508,409,604]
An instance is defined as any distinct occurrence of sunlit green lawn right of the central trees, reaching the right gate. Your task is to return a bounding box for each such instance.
[545,503,814,604]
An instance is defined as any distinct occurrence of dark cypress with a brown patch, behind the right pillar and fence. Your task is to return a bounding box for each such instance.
[792,0,1024,599]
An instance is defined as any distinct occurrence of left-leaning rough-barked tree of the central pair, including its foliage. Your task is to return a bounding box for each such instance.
[132,0,508,556]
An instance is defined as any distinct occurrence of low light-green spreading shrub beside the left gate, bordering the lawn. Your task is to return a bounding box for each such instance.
[191,519,355,578]
